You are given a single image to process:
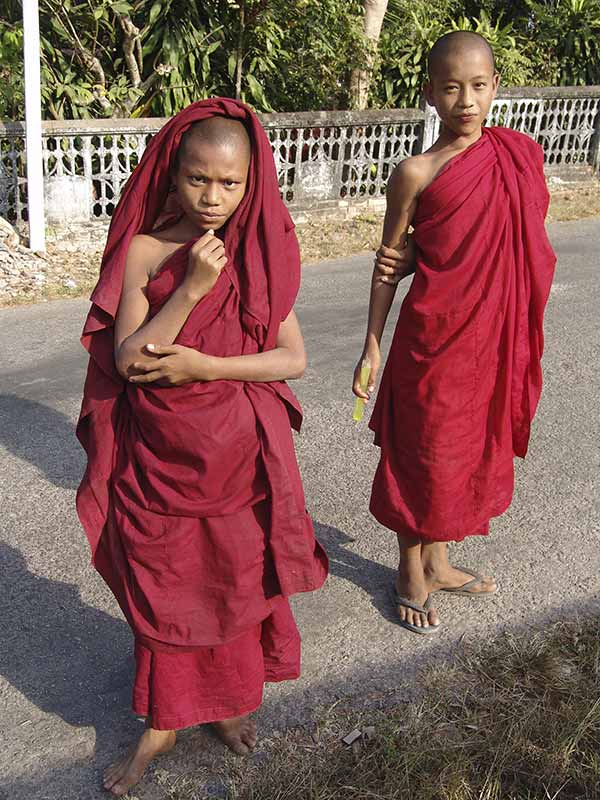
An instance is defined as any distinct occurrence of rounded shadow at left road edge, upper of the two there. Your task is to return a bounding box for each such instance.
[0,394,85,489]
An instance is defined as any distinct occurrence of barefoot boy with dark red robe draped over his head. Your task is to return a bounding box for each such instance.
[77,99,327,795]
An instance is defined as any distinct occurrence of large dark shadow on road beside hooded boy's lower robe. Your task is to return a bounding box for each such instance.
[0,542,140,798]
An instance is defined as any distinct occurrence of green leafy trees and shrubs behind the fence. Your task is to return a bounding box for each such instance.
[0,0,600,119]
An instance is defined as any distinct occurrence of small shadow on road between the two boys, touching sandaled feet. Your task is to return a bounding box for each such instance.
[314,522,397,622]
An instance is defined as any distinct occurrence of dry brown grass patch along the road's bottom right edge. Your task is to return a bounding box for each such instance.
[216,617,600,800]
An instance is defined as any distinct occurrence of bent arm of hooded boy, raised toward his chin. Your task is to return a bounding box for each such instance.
[115,236,222,377]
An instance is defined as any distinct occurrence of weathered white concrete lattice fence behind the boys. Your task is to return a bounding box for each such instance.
[0,86,600,222]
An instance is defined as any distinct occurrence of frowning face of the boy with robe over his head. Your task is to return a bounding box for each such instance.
[173,137,250,234]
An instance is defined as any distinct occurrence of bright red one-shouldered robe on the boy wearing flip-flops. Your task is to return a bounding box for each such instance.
[370,128,555,541]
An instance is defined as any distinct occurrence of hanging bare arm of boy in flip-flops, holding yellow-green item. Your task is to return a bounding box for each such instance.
[352,159,423,400]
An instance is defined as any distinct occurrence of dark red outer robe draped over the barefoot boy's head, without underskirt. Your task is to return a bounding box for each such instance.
[77,98,327,649]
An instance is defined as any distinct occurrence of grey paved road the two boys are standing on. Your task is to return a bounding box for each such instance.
[0,220,600,800]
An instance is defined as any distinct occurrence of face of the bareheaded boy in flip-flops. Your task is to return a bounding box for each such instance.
[425,47,500,136]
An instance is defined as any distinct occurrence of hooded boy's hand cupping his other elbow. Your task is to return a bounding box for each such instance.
[129,344,214,386]
